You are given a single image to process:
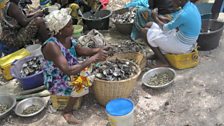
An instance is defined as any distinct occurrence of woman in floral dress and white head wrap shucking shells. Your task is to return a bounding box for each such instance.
[42,9,107,124]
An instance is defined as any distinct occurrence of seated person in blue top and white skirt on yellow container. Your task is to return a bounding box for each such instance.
[142,0,201,65]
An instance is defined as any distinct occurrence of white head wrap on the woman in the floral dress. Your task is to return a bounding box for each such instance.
[45,8,71,35]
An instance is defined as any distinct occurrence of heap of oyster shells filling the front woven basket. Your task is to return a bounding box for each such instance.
[93,59,138,81]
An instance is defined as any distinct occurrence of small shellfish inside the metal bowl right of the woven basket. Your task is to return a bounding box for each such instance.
[148,72,172,86]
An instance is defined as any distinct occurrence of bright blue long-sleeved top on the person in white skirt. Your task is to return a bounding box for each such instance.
[163,2,201,45]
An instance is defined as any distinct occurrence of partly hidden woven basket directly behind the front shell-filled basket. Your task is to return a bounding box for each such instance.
[109,52,146,70]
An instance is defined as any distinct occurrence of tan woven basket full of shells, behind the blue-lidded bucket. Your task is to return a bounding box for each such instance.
[93,59,141,106]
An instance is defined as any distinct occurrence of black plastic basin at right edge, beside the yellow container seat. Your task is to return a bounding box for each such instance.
[197,19,224,51]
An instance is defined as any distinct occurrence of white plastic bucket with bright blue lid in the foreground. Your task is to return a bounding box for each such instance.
[106,98,134,126]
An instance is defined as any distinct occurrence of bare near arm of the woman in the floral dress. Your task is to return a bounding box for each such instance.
[43,42,106,75]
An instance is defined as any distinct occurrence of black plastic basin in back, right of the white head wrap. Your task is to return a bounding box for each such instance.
[82,10,112,30]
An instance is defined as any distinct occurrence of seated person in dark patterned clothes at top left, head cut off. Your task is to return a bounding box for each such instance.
[0,0,49,53]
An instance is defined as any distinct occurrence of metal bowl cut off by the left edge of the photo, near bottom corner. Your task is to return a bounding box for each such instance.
[0,95,16,119]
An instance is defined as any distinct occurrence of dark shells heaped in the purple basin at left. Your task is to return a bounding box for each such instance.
[20,56,43,77]
